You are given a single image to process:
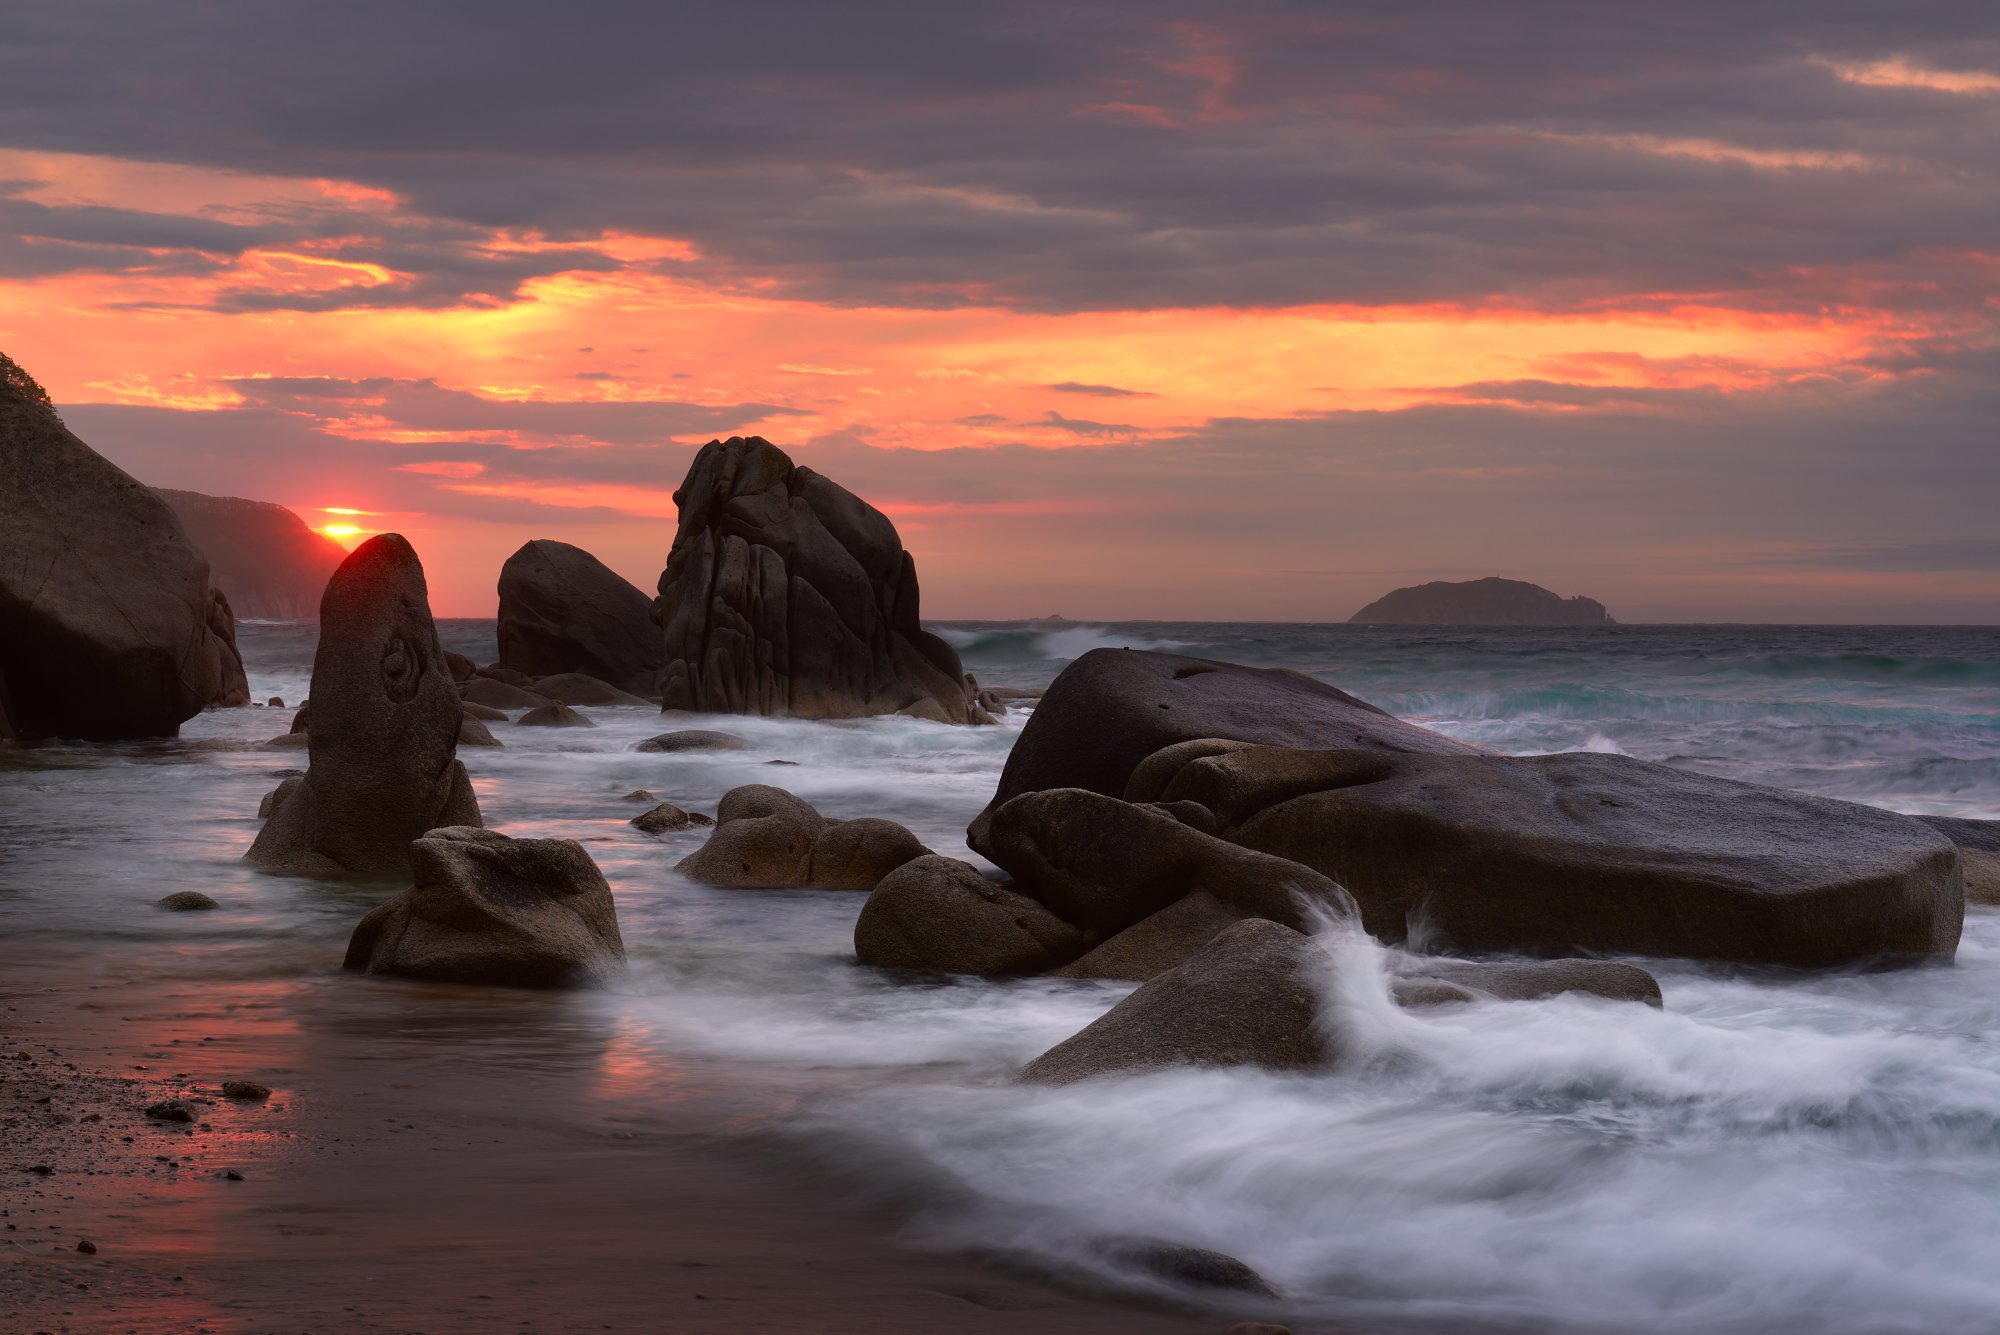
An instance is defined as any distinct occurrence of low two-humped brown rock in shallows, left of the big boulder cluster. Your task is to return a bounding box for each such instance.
[674,783,930,889]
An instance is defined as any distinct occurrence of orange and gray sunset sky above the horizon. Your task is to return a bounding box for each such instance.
[0,0,2000,622]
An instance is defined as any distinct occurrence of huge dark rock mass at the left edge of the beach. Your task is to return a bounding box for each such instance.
[0,358,250,741]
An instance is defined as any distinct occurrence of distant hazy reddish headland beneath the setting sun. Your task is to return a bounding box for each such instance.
[154,488,348,620]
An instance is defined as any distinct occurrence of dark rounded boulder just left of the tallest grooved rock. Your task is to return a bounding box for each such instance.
[498,538,666,705]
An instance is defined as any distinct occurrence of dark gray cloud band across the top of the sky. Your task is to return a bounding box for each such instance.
[0,0,2000,314]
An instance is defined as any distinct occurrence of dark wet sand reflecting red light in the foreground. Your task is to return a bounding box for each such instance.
[0,965,1254,1335]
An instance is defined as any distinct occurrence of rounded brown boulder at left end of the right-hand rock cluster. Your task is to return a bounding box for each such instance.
[854,853,1088,977]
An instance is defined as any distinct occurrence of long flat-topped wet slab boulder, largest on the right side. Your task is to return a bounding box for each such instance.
[1130,743,1964,967]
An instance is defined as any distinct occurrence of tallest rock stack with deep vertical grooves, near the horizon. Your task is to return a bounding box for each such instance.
[652,436,974,723]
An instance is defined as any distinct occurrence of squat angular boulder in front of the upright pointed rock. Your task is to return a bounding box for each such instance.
[342,827,624,987]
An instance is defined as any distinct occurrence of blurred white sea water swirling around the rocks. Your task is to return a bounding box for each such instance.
[0,622,2000,1333]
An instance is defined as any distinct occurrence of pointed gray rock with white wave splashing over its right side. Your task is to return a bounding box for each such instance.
[1016,919,1332,1085]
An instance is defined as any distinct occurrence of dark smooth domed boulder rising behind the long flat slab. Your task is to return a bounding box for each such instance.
[968,650,1480,857]
